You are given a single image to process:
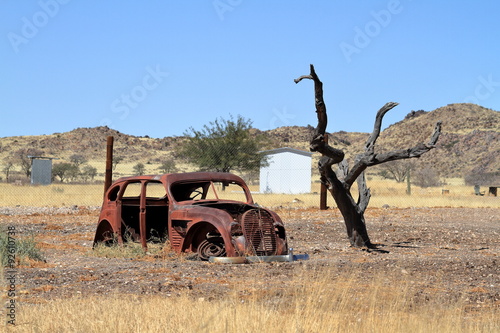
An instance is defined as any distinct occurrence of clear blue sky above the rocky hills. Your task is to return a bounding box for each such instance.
[0,0,500,138]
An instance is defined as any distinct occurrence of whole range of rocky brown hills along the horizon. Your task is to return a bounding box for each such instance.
[0,104,500,177]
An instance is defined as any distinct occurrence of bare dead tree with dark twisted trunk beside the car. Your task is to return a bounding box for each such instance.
[294,65,441,248]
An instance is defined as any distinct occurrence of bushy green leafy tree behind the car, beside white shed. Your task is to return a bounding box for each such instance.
[177,116,266,172]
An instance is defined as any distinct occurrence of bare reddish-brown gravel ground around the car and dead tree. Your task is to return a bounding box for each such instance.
[0,208,500,306]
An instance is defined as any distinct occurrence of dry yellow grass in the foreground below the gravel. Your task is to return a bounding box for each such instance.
[9,265,500,333]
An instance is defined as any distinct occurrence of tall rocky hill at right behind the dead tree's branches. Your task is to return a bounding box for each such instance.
[379,104,500,177]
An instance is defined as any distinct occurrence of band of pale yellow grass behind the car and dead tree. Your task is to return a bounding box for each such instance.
[0,179,500,208]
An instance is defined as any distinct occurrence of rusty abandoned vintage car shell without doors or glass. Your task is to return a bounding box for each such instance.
[94,172,288,260]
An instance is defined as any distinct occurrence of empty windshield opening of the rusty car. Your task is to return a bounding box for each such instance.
[171,181,247,202]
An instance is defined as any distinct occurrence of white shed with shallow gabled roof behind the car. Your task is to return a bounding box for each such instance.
[260,148,312,194]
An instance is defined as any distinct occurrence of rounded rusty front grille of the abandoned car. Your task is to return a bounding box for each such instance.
[241,209,276,256]
